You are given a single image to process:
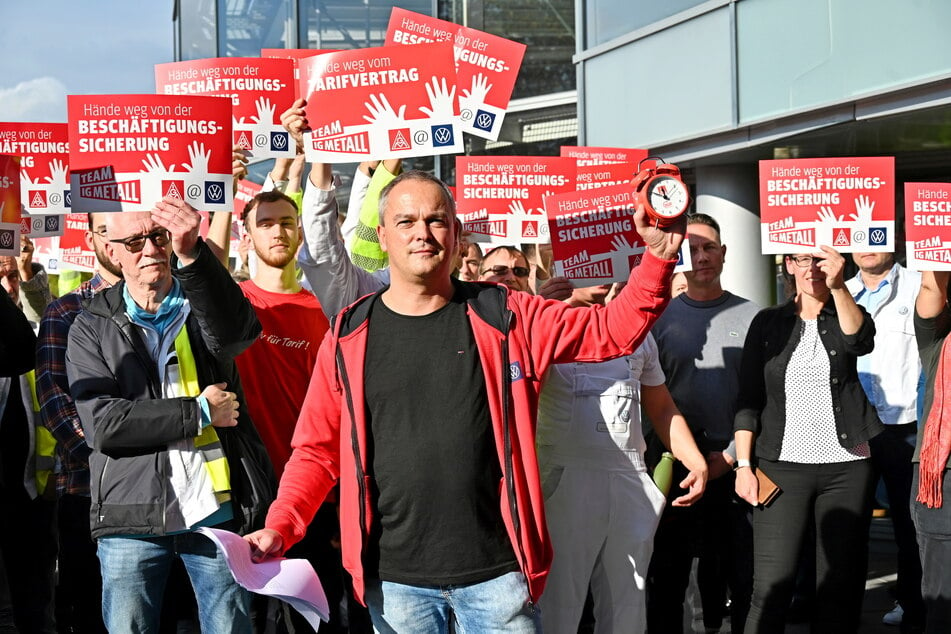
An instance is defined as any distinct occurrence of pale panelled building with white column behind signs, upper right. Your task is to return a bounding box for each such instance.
[574,0,951,303]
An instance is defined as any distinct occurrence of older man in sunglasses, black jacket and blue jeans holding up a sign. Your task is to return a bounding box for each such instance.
[66,197,275,634]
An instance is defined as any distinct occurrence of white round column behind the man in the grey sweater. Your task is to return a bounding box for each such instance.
[694,163,776,306]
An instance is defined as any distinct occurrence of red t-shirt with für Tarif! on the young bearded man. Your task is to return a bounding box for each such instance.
[236,280,330,478]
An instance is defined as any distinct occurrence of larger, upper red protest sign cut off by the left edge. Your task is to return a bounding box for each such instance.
[0,123,70,215]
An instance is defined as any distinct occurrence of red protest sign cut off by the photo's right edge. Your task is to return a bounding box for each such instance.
[905,183,951,271]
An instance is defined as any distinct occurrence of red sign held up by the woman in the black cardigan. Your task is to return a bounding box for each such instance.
[759,157,895,254]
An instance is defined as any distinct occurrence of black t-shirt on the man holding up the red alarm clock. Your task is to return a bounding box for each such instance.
[364,290,517,585]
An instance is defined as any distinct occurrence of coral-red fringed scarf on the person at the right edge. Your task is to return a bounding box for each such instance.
[918,336,951,508]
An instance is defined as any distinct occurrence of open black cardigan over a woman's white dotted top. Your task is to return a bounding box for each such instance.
[733,298,884,460]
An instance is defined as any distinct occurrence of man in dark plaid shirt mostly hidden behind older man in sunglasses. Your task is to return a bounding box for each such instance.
[36,213,122,634]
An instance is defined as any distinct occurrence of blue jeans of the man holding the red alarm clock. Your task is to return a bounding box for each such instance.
[364,572,541,634]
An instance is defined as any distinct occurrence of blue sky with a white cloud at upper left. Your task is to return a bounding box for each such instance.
[0,0,173,123]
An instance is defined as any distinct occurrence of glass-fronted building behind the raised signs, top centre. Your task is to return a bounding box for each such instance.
[175,0,578,182]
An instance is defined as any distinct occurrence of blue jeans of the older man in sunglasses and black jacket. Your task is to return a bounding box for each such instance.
[98,533,251,634]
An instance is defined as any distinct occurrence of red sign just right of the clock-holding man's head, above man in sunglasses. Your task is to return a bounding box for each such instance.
[456,156,577,244]
